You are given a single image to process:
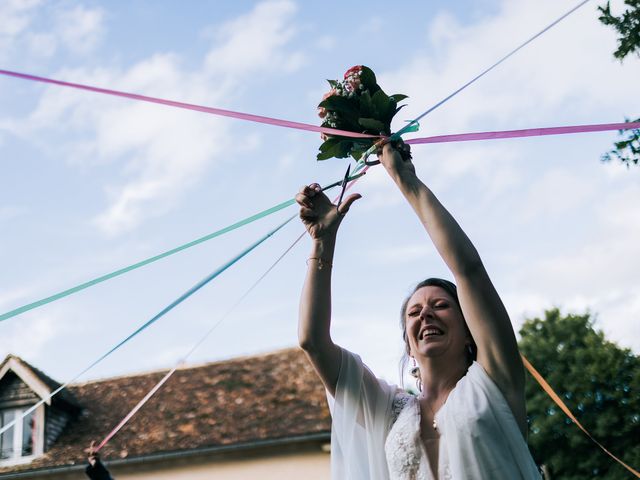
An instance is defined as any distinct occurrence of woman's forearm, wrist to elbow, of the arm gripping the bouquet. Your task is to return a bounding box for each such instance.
[392,172,481,278]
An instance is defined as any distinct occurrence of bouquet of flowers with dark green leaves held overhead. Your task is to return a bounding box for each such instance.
[317,65,407,160]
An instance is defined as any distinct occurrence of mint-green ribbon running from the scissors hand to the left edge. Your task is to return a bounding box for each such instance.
[0,174,362,321]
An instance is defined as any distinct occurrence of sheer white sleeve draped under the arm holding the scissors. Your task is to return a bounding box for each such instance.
[327,348,397,480]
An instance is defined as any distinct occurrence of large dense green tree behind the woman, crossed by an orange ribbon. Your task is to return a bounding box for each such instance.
[520,309,640,480]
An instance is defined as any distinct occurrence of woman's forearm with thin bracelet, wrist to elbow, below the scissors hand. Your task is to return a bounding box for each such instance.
[298,237,335,351]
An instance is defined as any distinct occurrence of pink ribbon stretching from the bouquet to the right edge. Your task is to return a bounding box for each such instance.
[405,122,640,145]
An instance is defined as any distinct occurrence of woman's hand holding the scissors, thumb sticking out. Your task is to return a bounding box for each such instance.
[296,183,362,240]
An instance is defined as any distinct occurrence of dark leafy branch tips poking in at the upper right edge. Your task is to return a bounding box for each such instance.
[598,0,640,168]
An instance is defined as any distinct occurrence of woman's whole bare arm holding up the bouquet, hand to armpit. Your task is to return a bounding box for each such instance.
[380,143,526,428]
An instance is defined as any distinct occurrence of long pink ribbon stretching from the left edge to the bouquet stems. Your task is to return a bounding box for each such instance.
[0,70,378,138]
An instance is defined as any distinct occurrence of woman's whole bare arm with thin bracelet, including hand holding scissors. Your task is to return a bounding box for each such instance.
[296,183,360,395]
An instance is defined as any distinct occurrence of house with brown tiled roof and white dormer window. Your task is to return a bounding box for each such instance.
[0,348,331,480]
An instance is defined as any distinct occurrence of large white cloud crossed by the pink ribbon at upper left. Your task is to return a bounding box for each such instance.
[8,55,227,234]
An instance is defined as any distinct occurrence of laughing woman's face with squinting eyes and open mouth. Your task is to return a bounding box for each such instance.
[405,286,470,357]
